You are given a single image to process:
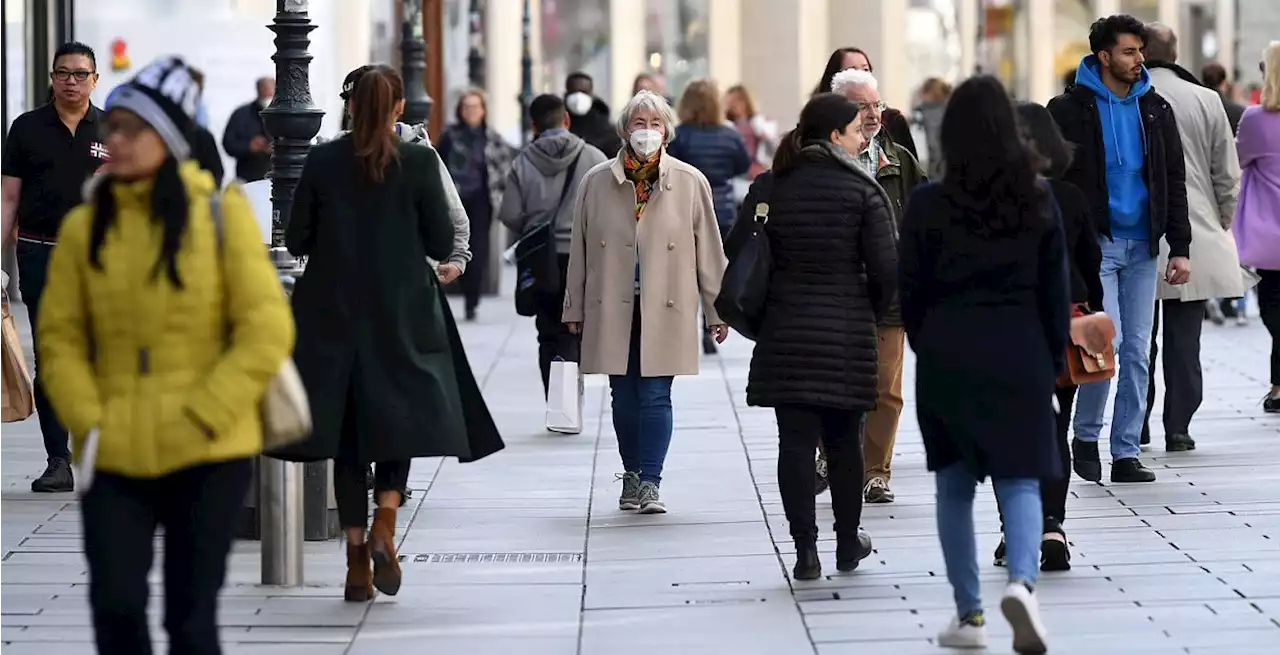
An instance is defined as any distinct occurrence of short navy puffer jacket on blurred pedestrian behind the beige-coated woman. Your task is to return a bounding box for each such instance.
[667,124,751,234]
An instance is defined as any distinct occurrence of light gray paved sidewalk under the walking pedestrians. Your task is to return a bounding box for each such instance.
[0,282,1280,655]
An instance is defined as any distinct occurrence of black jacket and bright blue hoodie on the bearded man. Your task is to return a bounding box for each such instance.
[1048,55,1192,257]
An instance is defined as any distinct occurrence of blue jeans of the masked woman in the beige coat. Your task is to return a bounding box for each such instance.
[609,308,673,485]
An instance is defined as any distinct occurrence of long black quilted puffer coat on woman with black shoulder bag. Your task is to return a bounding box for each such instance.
[746,143,897,411]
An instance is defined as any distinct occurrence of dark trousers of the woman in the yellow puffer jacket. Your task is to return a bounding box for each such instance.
[81,459,252,655]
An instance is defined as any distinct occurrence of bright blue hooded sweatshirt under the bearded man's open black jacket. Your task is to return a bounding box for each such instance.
[1075,55,1151,241]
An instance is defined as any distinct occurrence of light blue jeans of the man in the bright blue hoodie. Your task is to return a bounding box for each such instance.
[1075,237,1158,461]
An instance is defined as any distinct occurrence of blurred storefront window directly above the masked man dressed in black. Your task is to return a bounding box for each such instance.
[540,0,611,99]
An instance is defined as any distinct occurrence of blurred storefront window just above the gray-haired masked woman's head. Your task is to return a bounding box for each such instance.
[645,0,710,99]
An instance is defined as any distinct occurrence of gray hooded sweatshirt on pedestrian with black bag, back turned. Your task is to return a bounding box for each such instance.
[498,130,608,255]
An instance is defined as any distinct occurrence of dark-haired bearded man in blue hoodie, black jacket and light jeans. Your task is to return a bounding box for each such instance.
[1048,15,1192,482]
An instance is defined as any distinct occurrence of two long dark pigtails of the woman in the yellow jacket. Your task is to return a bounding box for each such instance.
[88,155,188,289]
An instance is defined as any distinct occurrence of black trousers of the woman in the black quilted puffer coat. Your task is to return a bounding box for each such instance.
[773,406,863,542]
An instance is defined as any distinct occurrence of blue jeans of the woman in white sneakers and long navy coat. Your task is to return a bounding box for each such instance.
[934,462,1044,617]
